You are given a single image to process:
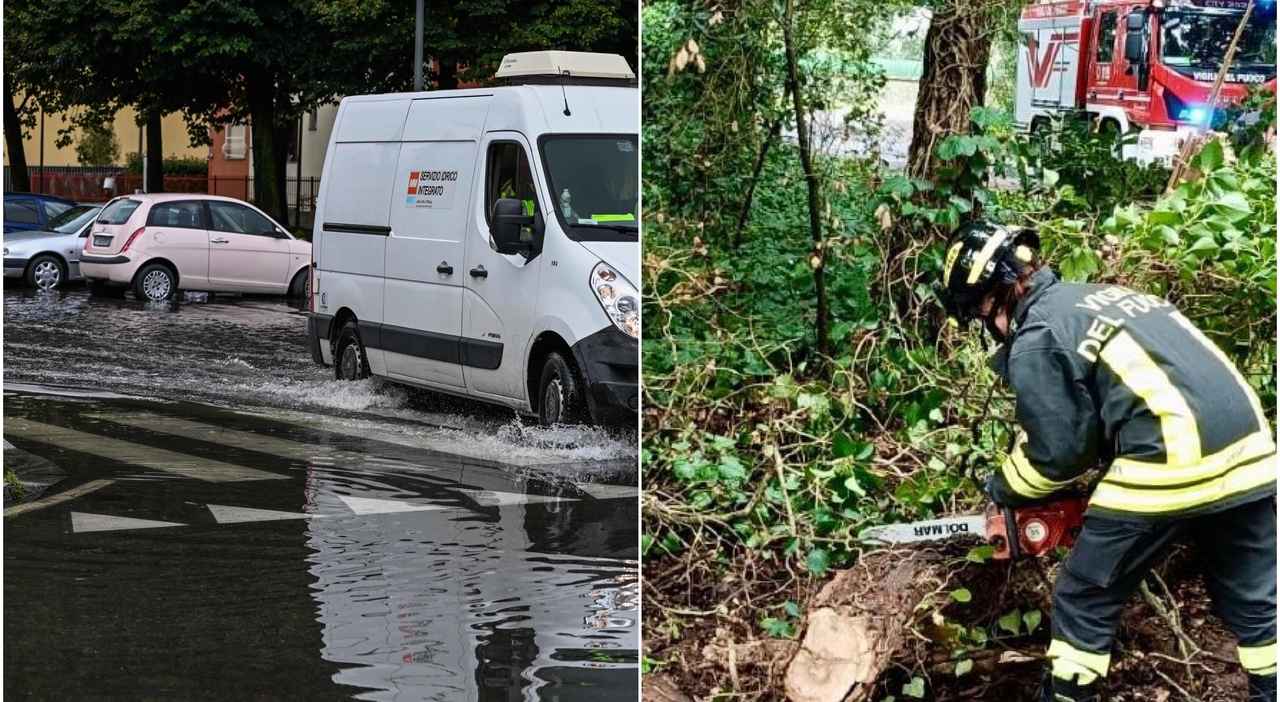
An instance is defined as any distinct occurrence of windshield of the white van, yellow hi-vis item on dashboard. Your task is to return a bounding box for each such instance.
[541,135,640,241]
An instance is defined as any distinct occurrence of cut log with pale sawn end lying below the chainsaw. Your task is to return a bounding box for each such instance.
[783,551,947,702]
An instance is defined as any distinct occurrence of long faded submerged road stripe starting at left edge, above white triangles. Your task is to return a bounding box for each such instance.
[4,418,287,483]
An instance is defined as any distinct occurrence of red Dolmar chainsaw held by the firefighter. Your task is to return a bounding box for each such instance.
[859,497,1088,560]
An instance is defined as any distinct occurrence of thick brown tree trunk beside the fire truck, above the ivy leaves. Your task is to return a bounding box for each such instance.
[908,0,1000,187]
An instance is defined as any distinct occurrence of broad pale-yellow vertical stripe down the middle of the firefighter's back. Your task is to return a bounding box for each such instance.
[1098,329,1201,465]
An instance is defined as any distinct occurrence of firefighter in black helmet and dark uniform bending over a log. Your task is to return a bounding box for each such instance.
[941,222,1276,702]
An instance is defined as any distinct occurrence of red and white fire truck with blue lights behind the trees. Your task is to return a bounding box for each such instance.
[1014,0,1276,163]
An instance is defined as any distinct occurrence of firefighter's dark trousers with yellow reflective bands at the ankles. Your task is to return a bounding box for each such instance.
[1048,497,1276,684]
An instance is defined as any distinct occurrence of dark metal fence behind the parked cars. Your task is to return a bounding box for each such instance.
[4,165,320,211]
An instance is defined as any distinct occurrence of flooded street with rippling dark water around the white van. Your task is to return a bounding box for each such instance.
[3,284,639,701]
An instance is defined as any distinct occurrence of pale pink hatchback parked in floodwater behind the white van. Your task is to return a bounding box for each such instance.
[81,193,311,301]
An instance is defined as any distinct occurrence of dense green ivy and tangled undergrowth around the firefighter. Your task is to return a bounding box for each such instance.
[641,3,1276,697]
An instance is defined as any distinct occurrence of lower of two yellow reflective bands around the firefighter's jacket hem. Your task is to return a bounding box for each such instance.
[1089,450,1276,514]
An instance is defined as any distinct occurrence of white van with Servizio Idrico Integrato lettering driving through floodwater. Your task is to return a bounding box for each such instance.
[300,51,640,424]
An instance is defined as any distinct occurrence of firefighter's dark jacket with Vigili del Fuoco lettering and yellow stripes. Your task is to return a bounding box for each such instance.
[993,268,1276,519]
